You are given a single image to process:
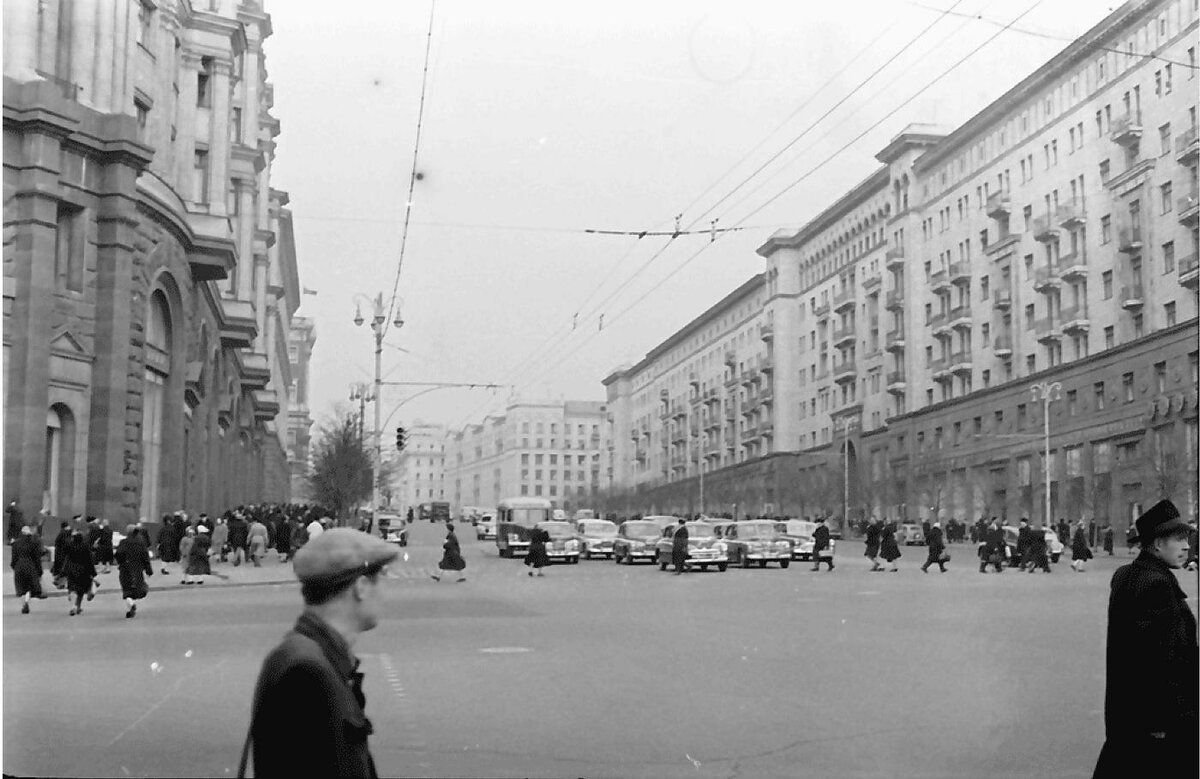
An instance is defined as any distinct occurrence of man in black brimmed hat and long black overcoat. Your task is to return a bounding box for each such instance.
[1093,501,1200,778]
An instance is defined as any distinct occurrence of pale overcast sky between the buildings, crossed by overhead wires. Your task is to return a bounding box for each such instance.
[266,0,1112,434]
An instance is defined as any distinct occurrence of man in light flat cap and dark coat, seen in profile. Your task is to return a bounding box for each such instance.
[239,528,400,777]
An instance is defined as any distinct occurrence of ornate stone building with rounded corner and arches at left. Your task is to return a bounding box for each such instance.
[4,0,300,523]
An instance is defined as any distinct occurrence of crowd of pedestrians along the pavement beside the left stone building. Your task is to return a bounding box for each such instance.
[6,502,332,618]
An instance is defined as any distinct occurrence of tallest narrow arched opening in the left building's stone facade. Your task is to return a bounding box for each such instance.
[139,290,173,520]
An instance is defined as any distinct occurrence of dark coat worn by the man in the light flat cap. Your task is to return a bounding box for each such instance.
[251,612,376,779]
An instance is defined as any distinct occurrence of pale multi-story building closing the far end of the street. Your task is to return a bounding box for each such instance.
[445,401,604,511]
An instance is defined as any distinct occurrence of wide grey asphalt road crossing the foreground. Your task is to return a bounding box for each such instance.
[4,523,1198,779]
